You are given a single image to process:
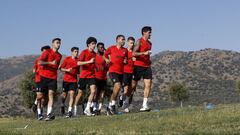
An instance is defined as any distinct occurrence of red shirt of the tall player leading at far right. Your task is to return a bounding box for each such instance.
[134,38,152,67]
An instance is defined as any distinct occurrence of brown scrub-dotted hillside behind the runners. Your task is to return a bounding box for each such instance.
[0,49,240,115]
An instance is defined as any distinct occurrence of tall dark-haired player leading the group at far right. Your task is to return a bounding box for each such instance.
[132,26,152,111]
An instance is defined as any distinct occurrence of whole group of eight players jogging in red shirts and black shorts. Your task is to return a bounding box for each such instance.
[33,26,152,121]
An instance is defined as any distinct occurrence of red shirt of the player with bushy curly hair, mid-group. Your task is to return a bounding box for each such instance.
[79,49,96,78]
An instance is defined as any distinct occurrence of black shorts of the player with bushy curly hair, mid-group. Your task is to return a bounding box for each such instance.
[78,78,96,90]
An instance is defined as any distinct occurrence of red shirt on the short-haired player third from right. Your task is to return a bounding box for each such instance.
[104,45,128,74]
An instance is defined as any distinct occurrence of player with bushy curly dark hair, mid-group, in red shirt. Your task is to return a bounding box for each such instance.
[74,37,97,116]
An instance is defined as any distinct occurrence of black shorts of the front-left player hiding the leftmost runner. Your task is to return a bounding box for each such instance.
[41,76,57,92]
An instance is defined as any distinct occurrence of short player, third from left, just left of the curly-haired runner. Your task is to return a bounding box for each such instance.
[60,47,79,118]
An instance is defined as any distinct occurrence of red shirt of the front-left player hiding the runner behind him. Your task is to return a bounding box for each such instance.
[39,49,62,80]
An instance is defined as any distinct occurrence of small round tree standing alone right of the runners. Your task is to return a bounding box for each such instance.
[169,82,189,107]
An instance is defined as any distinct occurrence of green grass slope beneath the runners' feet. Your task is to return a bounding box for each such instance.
[0,104,240,135]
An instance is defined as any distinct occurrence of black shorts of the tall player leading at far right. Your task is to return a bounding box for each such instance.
[133,66,152,81]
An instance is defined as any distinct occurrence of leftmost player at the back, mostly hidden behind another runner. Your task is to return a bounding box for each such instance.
[33,46,50,120]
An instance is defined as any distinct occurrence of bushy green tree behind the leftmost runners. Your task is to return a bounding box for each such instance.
[17,70,36,108]
